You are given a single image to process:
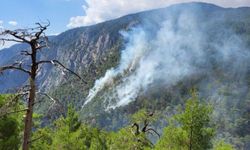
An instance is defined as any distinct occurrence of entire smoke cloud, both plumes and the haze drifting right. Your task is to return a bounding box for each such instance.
[84,7,250,109]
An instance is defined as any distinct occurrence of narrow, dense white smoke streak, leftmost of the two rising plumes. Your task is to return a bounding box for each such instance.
[83,29,147,106]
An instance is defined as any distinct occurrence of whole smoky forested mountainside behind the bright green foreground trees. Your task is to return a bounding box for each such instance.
[0,3,250,149]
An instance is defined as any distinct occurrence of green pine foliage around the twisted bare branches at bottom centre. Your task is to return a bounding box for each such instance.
[109,109,156,150]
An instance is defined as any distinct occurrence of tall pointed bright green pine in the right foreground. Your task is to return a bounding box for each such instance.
[175,91,214,150]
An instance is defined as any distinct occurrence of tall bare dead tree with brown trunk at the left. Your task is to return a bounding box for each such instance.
[0,21,86,150]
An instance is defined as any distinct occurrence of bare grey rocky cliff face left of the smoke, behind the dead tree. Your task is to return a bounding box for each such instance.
[0,16,141,93]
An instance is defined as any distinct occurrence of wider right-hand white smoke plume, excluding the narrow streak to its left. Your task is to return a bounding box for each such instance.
[109,13,203,108]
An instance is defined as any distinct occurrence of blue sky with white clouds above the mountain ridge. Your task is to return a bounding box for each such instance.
[0,0,250,34]
